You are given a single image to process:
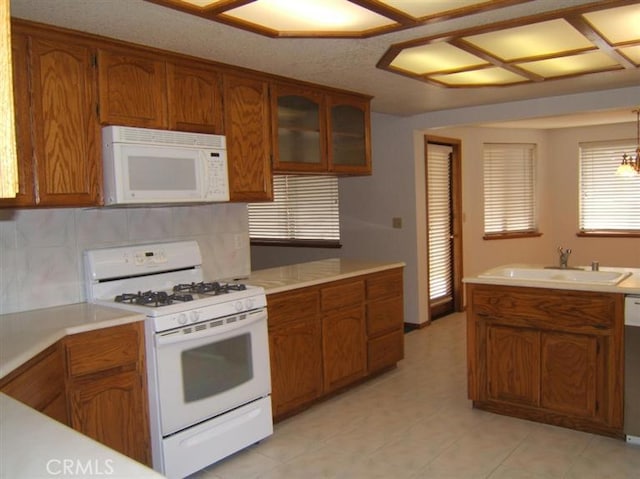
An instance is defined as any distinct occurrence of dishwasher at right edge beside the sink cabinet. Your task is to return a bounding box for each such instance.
[624,296,640,444]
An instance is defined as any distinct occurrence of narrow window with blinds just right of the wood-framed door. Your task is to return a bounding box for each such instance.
[483,143,538,239]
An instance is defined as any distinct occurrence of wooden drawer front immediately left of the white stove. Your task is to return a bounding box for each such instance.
[65,323,142,376]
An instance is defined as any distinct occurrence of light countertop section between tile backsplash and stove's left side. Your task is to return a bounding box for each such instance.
[0,303,144,378]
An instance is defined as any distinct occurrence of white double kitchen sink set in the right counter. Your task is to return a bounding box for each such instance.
[478,267,631,285]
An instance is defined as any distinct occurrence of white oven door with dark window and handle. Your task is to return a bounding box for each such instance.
[155,309,271,437]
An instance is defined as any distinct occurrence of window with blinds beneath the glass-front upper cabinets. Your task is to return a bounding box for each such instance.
[249,175,340,247]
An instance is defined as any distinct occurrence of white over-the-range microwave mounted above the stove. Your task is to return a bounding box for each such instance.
[102,126,229,205]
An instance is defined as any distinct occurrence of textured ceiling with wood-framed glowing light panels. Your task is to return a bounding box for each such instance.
[11,0,640,125]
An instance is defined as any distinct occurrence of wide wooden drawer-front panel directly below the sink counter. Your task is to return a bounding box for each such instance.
[470,287,622,329]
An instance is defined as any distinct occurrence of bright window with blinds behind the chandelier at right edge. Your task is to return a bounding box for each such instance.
[579,140,640,234]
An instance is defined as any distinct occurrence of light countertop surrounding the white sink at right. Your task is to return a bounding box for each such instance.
[463,264,640,294]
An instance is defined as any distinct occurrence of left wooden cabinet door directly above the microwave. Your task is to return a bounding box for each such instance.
[98,50,168,128]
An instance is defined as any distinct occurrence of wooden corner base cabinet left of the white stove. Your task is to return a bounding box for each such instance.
[0,322,151,466]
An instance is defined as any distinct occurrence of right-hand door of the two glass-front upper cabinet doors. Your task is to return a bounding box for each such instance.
[328,95,371,174]
